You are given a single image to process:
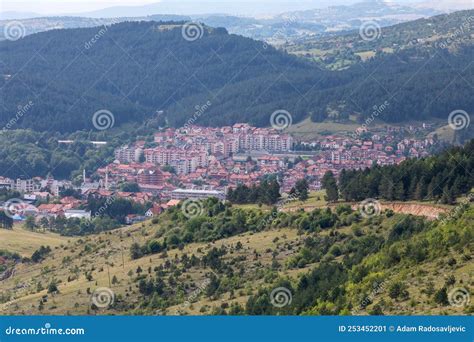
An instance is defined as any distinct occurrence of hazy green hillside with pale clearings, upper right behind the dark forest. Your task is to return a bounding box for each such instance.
[282,10,474,69]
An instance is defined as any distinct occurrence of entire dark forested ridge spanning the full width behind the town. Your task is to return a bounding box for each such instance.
[0,13,474,132]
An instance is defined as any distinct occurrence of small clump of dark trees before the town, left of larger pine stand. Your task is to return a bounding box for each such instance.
[227,179,282,205]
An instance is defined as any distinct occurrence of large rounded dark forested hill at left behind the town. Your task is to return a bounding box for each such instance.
[0,22,331,132]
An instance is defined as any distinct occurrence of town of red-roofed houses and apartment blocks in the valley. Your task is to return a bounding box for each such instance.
[0,123,436,224]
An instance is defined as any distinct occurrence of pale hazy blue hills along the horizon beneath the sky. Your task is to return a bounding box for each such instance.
[0,0,450,44]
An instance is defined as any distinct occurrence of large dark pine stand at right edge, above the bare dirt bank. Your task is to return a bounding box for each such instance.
[336,140,474,204]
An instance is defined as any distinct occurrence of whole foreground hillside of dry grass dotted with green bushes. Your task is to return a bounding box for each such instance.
[0,195,474,315]
